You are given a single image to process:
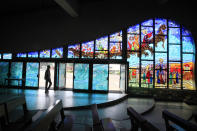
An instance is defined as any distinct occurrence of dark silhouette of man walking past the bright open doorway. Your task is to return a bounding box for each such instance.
[44,65,52,93]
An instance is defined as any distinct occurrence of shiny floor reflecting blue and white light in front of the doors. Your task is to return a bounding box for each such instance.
[0,89,126,110]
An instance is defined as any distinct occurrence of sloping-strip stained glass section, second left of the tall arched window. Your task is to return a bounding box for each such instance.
[95,36,108,59]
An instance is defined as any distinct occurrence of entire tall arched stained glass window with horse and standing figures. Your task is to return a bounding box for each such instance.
[127,18,195,90]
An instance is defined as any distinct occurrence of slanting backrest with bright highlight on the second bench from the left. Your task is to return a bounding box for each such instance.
[27,100,65,131]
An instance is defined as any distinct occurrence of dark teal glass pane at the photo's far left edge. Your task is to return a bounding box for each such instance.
[0,62,9,85]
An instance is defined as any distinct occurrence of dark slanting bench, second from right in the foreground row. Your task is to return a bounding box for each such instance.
[127,107,159,131]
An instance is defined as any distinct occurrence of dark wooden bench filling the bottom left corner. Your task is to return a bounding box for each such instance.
[0,96,35,131]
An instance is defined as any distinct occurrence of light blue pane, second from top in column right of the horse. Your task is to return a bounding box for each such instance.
[169,28,180,44]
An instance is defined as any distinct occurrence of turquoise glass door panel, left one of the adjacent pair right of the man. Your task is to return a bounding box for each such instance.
[74,64,89,90]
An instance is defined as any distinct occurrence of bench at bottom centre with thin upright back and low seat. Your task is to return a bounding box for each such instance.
[91,104,116,131]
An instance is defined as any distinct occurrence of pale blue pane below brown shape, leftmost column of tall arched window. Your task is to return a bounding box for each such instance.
[127,52,139,68]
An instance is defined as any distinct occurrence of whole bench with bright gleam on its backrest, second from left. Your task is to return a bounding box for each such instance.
[26,100,73,131]
